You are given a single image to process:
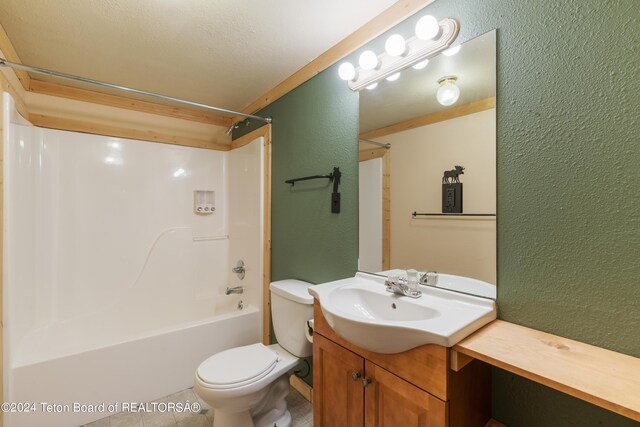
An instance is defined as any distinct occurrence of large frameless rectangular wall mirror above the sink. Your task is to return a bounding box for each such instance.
[359,30,496,298]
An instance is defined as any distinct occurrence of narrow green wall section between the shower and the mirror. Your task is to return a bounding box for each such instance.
[239,67,358,384]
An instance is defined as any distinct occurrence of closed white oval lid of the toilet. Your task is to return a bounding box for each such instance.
[197,343,278,388]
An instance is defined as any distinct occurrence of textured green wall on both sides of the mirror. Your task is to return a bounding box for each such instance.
[240,0,640,427]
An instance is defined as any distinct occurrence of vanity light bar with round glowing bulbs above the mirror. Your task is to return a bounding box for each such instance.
[338,15,460,91]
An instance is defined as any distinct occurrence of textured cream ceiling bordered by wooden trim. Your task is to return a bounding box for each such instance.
[0,0,394,110]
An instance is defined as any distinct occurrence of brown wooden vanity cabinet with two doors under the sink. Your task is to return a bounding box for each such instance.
[313,302,491,427]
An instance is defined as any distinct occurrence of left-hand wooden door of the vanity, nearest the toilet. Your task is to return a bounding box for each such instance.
[313,334,365,427]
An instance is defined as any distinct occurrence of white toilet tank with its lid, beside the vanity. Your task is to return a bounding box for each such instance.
[269,279,313,357]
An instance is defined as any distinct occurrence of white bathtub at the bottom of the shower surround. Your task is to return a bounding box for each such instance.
[5,296,261,427]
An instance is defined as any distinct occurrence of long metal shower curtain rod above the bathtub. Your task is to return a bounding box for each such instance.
[0,58,271,123]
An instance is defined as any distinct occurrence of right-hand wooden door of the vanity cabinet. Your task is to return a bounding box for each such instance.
[362,361,448,427]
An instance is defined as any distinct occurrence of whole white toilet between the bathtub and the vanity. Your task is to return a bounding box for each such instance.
[193,280,313,427]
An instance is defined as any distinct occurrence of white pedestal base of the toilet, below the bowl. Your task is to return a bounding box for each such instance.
[213,374,291,427]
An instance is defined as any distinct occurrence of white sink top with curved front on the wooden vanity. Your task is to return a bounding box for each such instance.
[309,273,496,354]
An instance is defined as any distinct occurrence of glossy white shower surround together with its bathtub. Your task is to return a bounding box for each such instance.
[3,93,264,427]
